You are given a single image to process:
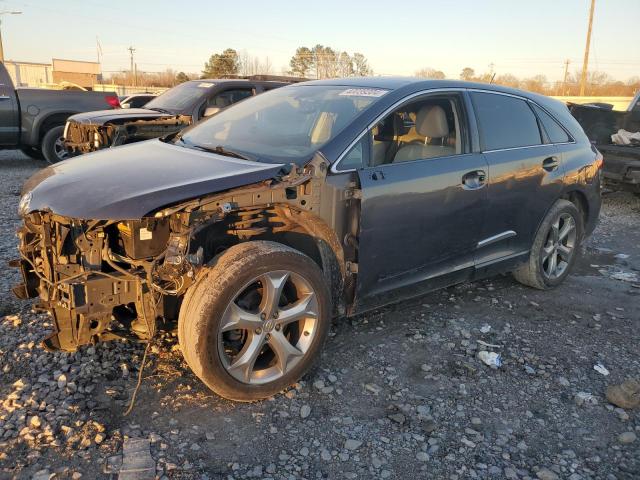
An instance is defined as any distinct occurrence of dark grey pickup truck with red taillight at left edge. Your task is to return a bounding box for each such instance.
[0,62,120,163]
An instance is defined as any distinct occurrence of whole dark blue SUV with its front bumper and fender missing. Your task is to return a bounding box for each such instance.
[14,78,602,401]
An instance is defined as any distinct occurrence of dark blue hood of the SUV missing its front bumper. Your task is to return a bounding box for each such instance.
[21,140,285,220]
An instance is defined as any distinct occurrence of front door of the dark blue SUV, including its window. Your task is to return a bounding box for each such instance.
[357,93,487,309]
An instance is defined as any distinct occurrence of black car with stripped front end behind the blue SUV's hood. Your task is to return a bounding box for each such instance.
[64,79,287,155]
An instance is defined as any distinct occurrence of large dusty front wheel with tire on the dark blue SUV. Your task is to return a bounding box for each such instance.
[178,241,331,402]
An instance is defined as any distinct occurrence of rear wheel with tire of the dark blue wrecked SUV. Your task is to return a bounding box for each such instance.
[513,200,584,290]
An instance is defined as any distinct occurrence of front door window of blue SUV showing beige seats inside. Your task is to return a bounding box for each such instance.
[370,95,466,167]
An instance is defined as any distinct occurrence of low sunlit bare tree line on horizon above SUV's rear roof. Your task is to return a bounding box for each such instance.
[414,67,640,97]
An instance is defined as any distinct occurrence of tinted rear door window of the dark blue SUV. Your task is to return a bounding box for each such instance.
[471,92,542,150]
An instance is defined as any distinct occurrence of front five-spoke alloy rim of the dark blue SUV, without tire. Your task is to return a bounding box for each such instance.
[218,270,318,384]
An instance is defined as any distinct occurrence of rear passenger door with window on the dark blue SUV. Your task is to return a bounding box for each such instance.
[470,91,564,267]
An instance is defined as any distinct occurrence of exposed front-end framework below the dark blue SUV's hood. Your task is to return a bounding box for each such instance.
[14,158,355,351]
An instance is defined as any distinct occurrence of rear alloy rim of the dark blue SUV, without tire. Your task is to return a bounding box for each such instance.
[542,213,577,280]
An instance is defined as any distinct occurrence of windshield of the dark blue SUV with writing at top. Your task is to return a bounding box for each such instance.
[179,85,387,163]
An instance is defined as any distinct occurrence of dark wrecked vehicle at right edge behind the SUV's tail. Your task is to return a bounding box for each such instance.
[569,92,640,195]
